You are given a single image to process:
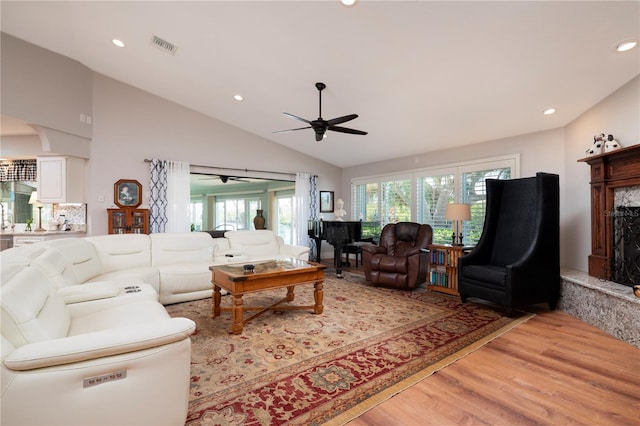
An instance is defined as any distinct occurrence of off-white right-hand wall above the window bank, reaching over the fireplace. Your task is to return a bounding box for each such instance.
[342,77,640,272]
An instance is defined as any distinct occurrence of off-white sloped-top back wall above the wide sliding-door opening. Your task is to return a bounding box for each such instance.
[87,74,342,235]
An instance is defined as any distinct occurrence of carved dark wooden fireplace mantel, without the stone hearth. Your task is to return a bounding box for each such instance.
[578,144,640,280]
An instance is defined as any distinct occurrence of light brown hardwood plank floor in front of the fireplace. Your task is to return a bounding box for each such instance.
[330,267,640,426]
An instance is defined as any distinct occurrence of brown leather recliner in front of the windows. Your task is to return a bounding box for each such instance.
[362,222,433,289]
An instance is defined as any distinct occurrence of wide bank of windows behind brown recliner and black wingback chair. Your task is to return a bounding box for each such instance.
[352,155,520,245]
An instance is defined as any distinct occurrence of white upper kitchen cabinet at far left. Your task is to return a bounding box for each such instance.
[38,157,86,203]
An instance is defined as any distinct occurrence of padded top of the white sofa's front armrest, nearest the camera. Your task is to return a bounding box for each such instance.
[4,318,196,371]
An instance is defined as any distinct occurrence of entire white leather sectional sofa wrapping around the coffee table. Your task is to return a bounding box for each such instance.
[0,230,309,425]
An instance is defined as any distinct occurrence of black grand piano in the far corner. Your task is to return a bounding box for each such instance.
[308,220,362,278]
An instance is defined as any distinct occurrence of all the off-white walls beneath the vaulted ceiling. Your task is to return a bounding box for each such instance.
[1,34,640,271]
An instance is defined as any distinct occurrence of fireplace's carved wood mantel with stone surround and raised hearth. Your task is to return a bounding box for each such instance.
[558,145,640,347]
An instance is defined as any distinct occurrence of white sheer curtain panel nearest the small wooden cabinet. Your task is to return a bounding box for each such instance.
[166,161,191,232]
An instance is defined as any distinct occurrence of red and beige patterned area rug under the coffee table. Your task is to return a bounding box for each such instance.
[167,270,530,426]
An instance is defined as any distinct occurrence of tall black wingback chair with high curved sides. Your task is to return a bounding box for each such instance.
[458,173,560,314]
